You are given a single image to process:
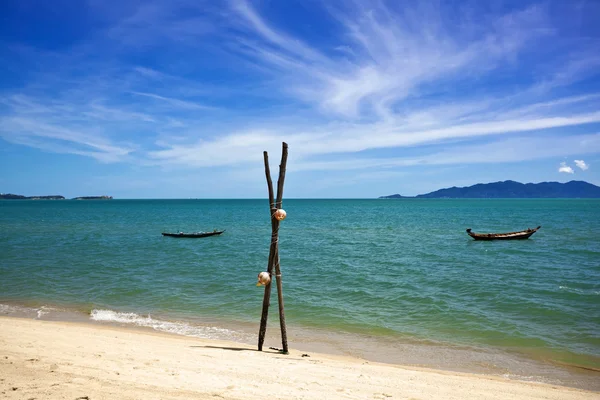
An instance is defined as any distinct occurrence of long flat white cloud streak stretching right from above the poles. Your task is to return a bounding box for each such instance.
[145,113,600,169]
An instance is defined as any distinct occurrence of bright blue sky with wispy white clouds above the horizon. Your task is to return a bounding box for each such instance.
[0,0,600,198]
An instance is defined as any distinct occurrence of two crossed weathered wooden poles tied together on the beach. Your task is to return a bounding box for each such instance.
[258,142,288,354]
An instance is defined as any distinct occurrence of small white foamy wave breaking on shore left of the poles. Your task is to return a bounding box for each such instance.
[90,309,247,340]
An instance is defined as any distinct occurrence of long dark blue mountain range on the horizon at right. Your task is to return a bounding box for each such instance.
[379,181,600,199]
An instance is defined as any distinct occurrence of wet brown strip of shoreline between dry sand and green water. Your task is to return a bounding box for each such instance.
[0,301,600,391]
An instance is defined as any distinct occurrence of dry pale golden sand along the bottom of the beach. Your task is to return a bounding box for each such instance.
[0,317,600,400]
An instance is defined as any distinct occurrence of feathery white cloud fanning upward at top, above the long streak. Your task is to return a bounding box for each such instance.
[234,1,546,117]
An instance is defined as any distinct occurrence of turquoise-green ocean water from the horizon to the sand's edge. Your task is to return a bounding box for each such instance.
[0,199,600,390]
